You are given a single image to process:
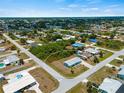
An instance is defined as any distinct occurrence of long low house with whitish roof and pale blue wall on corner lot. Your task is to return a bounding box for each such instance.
[64,57,82,67]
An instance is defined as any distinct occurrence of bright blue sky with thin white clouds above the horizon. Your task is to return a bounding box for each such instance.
[0,0,124,17]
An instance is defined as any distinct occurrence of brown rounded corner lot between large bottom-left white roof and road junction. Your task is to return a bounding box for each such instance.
[29,68,59,93]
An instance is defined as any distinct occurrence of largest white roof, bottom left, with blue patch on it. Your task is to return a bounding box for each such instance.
[3,71,36,93]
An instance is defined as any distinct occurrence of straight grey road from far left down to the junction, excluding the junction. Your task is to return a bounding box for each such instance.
[3,34,65,81]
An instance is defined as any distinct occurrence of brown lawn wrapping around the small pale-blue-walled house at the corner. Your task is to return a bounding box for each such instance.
[47,55,88,78]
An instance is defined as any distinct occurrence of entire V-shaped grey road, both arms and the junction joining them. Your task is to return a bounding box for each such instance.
[4,34,124,93]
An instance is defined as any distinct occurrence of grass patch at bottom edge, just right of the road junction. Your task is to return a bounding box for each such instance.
[66,83,88,93]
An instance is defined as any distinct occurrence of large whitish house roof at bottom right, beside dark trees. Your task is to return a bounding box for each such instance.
[99,78,122,93]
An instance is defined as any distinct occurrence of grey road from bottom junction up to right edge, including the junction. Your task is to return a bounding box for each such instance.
[53,50,124,93]
